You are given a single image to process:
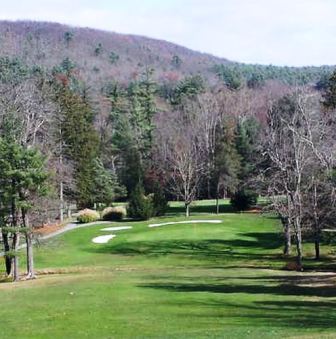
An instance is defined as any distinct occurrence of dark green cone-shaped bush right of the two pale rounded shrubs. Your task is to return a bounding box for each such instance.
[127,184,153,220]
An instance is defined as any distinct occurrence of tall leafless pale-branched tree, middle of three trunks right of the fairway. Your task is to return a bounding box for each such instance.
[265,91,313,269]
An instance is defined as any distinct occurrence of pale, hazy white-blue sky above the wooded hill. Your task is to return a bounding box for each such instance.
[0,0,336,66]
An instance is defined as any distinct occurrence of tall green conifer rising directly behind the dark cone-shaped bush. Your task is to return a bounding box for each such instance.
[107,69,157,194]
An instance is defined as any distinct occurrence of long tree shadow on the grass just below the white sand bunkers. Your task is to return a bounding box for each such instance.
[87,233,282,268]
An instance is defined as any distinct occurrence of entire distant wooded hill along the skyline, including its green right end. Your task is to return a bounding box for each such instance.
[0,21,333,87]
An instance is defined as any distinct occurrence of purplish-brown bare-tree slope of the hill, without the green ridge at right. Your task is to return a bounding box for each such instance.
[0,21,227,84]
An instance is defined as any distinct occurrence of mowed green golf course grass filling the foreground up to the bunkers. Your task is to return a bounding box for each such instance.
[0,203,336,338]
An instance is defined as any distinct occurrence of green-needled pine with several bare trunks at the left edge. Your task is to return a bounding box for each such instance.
[0,139,48,281]
